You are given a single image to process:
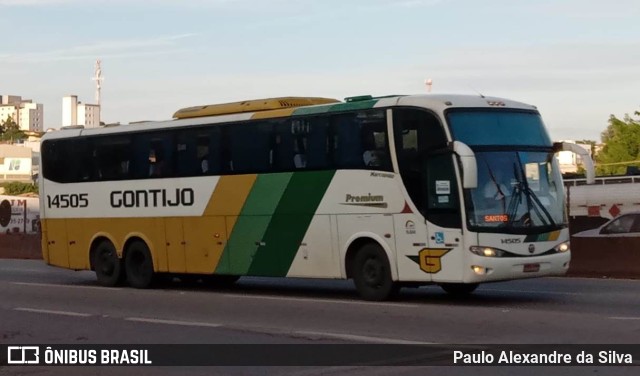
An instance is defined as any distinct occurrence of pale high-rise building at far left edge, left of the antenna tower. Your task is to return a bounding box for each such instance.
[0,95,44,132]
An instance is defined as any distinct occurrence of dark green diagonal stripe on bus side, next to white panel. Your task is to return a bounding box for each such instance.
[248,171,335,277]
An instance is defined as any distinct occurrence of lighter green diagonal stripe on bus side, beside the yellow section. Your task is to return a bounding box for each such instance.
[216,173,293,275]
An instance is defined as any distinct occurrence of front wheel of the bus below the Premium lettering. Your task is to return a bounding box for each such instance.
[351,243,398,301]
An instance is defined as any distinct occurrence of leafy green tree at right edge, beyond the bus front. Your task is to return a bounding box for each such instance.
[596,111,640,175]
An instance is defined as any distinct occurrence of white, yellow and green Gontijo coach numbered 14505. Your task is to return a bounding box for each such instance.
[39,94,593,300]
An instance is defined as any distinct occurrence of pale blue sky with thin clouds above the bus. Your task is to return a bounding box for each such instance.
[0,0,640,141]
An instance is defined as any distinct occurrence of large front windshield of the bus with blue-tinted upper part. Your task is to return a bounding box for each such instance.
[448,110,565,234]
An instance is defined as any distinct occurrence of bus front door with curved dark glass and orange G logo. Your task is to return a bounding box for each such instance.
[393,108,462,281]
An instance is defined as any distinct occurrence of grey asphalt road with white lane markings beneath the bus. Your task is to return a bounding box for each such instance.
[0,260,640,375]
